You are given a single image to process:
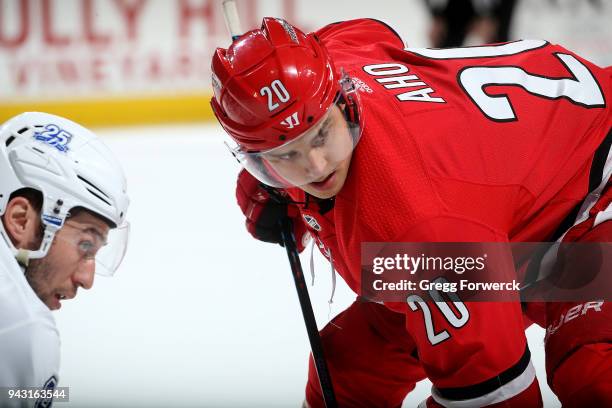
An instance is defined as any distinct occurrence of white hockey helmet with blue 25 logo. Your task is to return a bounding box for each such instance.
[0,112,129,275]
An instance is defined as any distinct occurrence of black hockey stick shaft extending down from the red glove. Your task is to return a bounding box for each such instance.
[281,217,338,408]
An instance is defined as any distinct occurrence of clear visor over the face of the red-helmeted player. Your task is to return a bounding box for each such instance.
[230,77,361,188]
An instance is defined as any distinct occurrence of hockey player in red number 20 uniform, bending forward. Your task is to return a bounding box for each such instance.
[212,18,612,407]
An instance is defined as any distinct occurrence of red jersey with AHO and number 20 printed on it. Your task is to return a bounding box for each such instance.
[290,20,612,405]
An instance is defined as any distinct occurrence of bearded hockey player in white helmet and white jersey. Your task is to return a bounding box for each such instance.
[0,112,129,407]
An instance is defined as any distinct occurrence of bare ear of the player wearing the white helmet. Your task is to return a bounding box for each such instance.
[2,196,40,249]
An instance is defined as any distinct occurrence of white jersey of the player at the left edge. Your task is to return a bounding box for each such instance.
[0,242,60,407]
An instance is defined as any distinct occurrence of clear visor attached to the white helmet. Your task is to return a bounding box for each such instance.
[55,222,130,276]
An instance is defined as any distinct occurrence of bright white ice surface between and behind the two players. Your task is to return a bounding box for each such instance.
[55,125,558,407]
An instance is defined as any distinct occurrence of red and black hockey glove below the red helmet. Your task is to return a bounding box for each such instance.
[236,169,307,252]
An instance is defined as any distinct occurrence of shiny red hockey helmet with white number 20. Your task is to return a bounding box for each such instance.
[211,17,358,186]
